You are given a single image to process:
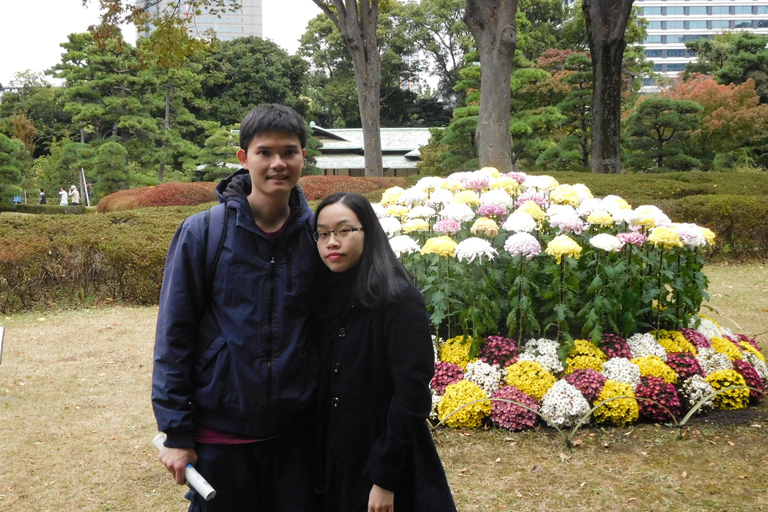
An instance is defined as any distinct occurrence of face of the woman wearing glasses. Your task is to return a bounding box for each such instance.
[317,203,365,272]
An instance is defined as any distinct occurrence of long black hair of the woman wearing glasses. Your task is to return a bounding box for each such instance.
[315,192,411,308]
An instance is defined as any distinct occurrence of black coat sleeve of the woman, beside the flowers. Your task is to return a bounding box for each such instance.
[363,286,434,491]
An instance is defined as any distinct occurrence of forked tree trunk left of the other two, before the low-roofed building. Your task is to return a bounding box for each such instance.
[313,0,384,176]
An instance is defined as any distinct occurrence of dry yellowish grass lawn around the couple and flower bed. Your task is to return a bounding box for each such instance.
[0,264,768,512]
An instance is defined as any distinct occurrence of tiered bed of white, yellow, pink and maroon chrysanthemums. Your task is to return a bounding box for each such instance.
[374,168,768,430]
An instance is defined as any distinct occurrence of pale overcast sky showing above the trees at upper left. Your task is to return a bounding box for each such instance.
[0,0,320,85]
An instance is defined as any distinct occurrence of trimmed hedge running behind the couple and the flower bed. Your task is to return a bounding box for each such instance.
[0,173,768,314]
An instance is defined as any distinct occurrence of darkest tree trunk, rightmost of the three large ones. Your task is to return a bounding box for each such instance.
[581,0,633,174]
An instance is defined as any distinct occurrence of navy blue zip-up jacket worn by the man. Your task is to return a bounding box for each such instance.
[152,170,321,448]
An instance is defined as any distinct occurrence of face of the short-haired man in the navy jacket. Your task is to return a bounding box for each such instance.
[237,132,306,196]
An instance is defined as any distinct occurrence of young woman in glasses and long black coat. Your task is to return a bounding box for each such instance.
[314,192,456,512]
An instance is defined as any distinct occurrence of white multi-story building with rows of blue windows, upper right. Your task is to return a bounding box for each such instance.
[564,0,768,90]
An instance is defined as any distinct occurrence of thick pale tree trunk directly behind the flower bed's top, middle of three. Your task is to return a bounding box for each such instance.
[464,0,517,173]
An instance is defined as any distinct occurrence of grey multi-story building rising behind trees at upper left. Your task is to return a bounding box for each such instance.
[145,0,264,41]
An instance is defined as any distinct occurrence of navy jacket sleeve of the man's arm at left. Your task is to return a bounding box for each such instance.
[152,215,205,448]
